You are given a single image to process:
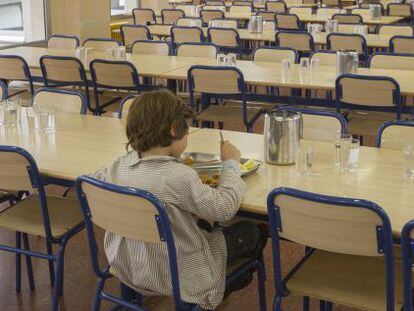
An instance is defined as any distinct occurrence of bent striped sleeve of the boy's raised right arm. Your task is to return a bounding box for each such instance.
[179,160,246,221]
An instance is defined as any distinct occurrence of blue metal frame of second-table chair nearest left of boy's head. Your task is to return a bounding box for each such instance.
[89,59,157,114]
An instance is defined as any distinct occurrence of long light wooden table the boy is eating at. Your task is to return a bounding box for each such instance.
[0,113,414,237]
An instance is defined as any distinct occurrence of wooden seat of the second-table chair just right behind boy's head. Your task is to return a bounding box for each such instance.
[197,105,262,122]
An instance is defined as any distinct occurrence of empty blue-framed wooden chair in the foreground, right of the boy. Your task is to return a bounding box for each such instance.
[267,188,401,311]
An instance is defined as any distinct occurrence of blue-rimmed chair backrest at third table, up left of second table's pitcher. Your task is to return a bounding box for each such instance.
[276,31,314,52]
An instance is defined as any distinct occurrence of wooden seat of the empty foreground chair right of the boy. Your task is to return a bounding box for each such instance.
[286,250,403,311]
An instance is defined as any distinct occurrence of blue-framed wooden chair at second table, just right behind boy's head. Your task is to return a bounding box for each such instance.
[187,66,264,133]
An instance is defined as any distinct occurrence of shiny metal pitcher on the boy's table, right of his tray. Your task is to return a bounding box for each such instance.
[264,110,302,165]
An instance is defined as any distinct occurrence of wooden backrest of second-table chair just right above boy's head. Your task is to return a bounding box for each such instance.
[188,66,245,95]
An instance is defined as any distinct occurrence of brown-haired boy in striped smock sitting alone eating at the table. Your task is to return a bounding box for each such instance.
[94,90,267,309]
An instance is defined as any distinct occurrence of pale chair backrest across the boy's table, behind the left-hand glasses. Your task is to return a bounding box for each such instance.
[32,88,87,114]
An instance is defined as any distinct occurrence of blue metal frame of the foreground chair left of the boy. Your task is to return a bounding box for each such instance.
[0,145,84,311]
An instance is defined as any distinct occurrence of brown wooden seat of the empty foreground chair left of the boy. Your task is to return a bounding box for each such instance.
[0,194,83,238]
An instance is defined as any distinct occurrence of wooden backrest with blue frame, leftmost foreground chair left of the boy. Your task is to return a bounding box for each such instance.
[0,145,53,241]
